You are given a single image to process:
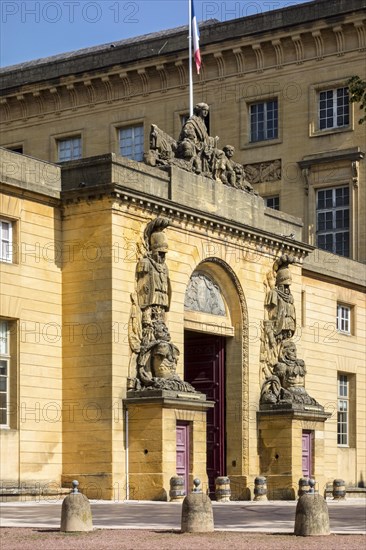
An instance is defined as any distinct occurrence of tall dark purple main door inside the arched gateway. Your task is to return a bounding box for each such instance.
[184,331,226,497]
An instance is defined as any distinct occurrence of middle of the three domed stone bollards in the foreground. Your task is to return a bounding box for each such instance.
[181,479,214,533]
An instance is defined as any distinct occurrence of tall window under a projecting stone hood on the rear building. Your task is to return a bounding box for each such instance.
[316,187,350,258]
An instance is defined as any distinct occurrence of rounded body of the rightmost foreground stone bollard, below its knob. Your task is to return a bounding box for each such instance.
[294,493,330,537]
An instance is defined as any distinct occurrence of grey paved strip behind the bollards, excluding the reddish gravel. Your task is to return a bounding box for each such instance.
[0,499,366,534]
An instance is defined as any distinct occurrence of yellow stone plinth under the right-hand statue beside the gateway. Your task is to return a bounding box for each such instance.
[257,405,330,500]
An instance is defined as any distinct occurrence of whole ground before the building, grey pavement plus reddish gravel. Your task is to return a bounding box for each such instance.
[0,499,366,550]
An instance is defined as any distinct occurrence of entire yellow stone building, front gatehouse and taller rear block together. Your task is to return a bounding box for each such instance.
[0,0,366,499]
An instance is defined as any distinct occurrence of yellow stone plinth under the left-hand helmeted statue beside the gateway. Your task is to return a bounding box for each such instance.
[124,390,214,501]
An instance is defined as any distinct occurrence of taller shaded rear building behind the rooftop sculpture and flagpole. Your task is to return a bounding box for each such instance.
[0,0,366,261]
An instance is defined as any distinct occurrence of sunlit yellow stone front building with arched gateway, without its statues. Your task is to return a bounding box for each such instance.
[1,150,365,499]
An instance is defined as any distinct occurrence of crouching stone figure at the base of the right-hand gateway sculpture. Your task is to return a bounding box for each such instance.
[260,340,320,407]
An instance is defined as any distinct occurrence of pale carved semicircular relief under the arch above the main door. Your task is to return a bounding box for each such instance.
[184,272,226,315]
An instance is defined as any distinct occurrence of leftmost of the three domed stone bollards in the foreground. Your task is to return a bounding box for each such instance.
[60,480,93,533]
